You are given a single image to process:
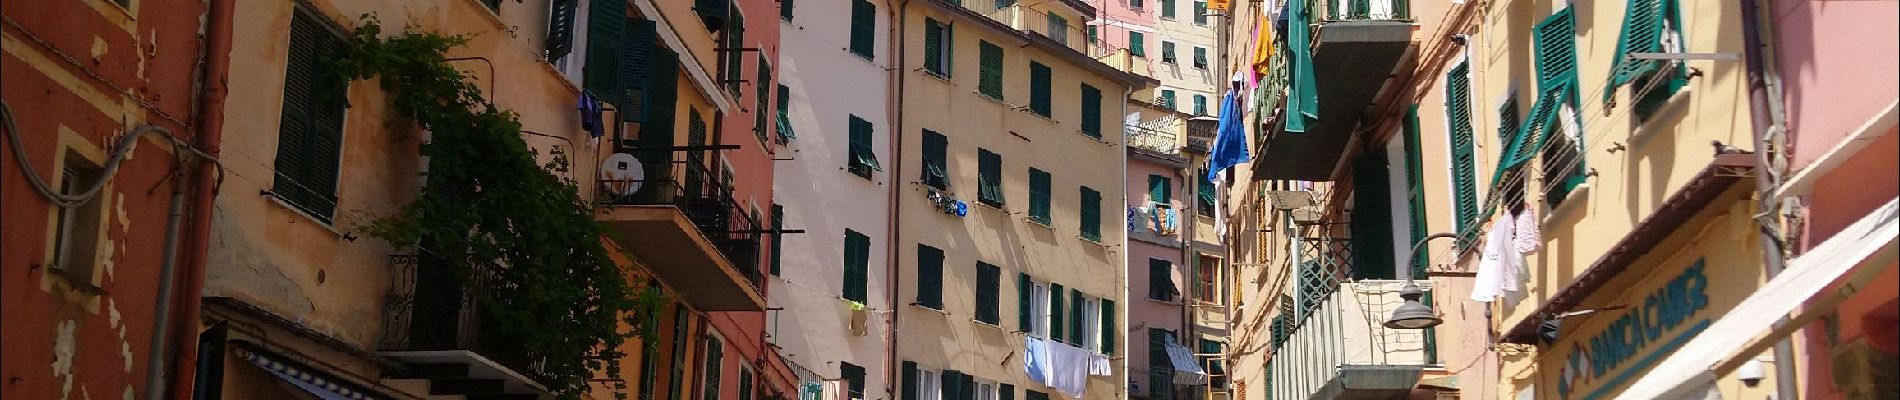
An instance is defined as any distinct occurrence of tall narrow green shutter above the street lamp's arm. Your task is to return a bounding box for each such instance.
[1444,63,1478,233]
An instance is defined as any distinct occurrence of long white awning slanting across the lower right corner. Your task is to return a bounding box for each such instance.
[1617,199,1900,400]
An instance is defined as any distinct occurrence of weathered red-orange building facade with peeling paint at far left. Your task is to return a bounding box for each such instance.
[0,0,217,398]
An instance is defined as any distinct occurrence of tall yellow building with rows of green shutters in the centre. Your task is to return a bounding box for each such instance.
[881,0,1153,400]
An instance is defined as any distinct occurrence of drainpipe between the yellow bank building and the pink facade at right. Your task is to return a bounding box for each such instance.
[1740,0,1801,400]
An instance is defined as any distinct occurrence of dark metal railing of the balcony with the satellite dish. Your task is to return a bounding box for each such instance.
[600,155,766,288]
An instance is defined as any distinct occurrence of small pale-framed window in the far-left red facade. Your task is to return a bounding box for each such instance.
[51,152,110,288]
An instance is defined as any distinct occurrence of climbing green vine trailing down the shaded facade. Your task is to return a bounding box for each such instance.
[333,15,659,398]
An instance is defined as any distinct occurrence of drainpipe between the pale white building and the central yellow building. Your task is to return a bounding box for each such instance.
[884,0,910,396]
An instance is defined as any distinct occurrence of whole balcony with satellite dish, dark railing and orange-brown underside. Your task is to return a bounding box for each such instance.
[597,156,766,311]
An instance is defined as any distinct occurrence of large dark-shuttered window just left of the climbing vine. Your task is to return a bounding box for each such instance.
[272,8,348,224]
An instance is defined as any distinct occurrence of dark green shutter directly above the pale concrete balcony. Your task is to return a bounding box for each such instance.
[1351,148,1398,281]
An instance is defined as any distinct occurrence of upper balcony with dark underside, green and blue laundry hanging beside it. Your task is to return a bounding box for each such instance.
[1254,0,1414,180]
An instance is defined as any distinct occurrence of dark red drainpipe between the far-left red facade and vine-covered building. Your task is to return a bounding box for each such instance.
[164,0,236,398]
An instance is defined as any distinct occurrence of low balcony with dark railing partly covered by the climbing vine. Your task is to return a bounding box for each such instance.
[376,256,551,398]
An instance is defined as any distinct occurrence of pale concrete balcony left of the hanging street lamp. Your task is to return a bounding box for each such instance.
[1267,281,1435,400]
